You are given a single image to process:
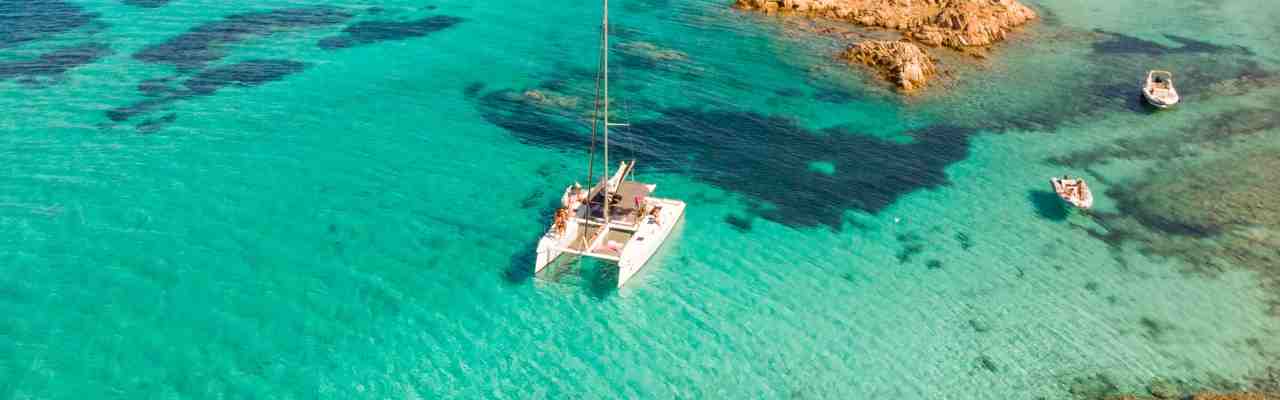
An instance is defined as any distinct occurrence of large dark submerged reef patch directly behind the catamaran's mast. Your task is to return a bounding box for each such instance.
[468,82,975,229]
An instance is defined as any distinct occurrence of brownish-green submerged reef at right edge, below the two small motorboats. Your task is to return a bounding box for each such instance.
[1093,147,1280,318]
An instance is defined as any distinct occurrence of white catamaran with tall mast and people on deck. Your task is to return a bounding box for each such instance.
[534,0,685,287]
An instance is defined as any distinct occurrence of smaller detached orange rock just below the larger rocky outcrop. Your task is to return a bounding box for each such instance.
[840,40,937,91]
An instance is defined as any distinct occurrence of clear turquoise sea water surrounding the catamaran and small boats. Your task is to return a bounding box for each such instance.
[0,0,1280,399]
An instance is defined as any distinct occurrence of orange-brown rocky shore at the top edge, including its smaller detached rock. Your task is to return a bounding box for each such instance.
[735,0,1038,91]
